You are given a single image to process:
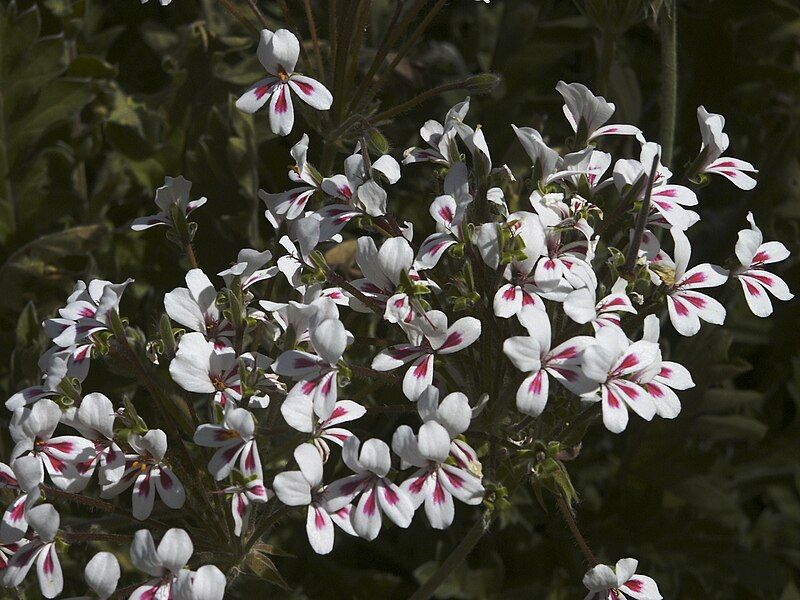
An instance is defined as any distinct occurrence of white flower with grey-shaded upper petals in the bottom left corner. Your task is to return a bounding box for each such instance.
[2,504,64,598]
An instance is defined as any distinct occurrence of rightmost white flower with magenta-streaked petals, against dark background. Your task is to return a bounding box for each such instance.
[731,212,794,317]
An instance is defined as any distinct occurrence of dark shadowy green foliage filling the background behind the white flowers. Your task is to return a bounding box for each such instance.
[0,0,800,600]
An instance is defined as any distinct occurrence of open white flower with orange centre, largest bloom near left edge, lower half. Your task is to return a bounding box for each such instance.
[9,398,95,492]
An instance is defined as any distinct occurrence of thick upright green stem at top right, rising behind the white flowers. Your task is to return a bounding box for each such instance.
[659,0,678,167]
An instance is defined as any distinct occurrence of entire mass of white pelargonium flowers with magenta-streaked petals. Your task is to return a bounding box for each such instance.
[0,23,792,599]
